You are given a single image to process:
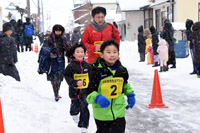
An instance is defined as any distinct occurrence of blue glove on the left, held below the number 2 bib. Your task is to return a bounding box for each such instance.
[95,94,110,108]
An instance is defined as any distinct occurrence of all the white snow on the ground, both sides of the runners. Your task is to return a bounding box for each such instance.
[0,41,200,133]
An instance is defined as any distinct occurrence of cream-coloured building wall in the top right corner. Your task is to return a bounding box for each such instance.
[174,0,200,23]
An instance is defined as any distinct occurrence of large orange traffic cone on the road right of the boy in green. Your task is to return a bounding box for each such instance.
[147,69,168,108]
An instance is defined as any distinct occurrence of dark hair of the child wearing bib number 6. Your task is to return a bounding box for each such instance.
[66,42,86,58]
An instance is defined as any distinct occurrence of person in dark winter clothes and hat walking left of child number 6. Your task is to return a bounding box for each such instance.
[43,24,69,101]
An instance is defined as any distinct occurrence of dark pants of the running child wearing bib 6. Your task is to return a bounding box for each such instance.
[70,97,90,128]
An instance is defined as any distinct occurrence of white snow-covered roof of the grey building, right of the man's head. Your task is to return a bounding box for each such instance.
[118,0,151,11]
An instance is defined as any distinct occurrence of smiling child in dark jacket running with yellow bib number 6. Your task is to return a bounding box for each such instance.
[64,43,91,132]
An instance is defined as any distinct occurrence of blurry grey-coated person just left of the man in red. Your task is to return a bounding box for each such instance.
[71,24,81,45]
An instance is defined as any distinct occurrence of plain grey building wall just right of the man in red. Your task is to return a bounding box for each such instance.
[125,11,144,41]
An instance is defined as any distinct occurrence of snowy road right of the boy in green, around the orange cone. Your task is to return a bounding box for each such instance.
[121,43,200,133]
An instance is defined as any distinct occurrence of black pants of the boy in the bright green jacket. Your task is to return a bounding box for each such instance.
[95,117,126,133]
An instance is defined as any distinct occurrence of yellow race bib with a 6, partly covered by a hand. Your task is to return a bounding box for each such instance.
[74,73,89,89]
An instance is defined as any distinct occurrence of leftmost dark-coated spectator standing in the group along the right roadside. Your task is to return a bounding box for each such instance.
[138,25,146,62]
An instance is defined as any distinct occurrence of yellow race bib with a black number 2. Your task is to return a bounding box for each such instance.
[101,77,124,99]
